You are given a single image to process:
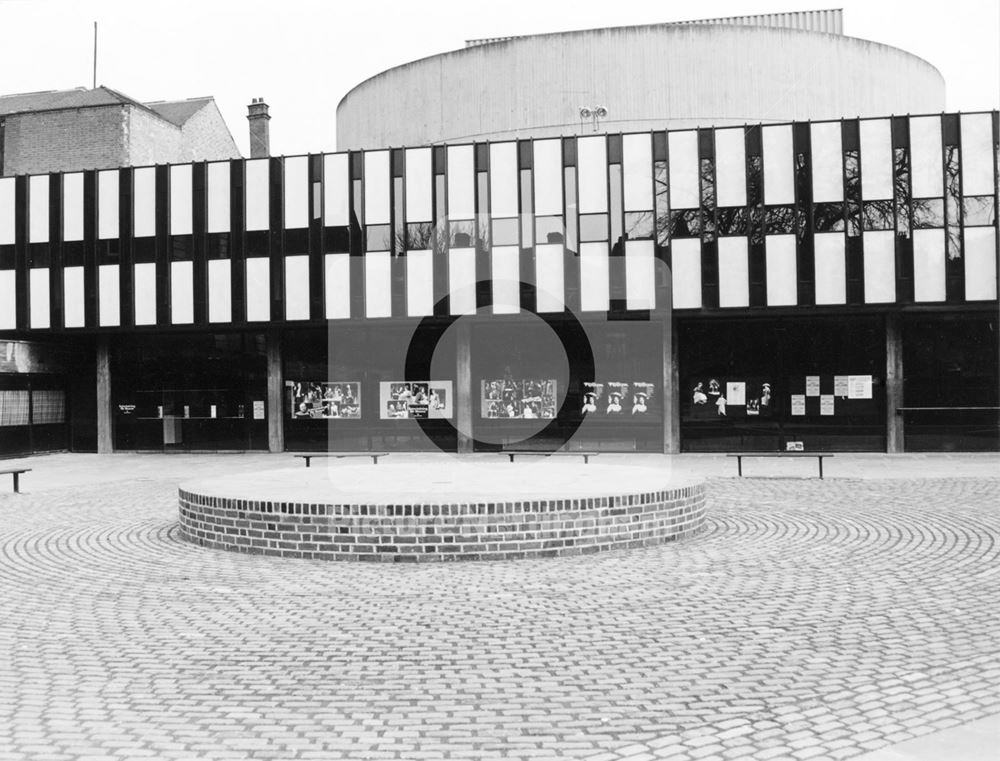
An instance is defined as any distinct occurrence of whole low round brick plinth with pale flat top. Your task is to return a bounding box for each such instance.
[178,463,705,562]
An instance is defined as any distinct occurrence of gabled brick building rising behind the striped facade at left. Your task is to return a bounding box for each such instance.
[0,86,240,175]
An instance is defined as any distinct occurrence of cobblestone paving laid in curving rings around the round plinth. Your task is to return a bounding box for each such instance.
[0,472,1000,761]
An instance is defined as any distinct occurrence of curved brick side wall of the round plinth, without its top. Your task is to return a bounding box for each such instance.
[178,484,705,562]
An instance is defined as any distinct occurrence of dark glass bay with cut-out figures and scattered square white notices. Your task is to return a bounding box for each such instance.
[679,316,886,452]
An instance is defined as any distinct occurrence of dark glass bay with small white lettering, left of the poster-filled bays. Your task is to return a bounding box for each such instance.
[111,333,267,451]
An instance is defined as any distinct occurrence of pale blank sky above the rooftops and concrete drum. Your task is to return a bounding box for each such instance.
[0,0,1000,154]
